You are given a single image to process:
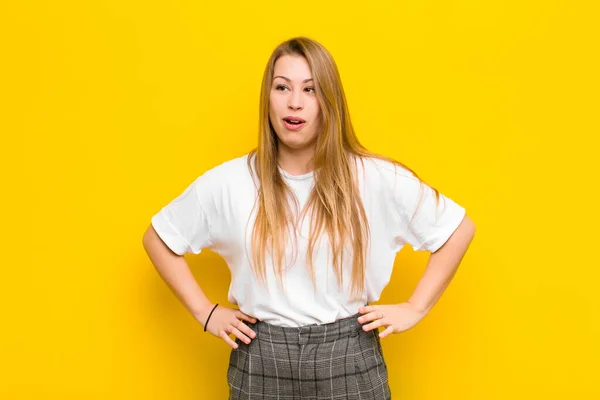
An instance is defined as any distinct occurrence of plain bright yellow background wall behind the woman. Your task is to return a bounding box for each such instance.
[0,0,600,400]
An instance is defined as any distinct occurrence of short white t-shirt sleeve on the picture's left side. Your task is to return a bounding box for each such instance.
[152,176,211,255]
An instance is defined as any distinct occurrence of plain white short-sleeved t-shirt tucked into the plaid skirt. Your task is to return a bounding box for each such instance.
[152,154,465,327]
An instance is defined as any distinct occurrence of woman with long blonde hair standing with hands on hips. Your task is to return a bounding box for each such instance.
[144,37,475,399]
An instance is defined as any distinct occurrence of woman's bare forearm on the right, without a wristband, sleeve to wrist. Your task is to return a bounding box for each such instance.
[408,215,475,315]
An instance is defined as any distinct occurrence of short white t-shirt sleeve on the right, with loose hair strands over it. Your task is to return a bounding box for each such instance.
[388,165,466,253]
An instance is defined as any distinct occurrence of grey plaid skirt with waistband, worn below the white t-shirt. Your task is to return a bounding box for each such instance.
[227,314,391,400]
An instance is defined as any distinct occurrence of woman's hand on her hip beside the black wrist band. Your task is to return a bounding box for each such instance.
[200,304,256,349]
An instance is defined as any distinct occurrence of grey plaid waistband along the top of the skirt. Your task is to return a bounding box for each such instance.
[248,313,362,344]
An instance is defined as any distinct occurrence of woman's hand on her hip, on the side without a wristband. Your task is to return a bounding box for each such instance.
[358,302,426,338]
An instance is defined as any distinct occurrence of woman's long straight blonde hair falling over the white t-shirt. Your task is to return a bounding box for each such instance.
[248,37,439,298]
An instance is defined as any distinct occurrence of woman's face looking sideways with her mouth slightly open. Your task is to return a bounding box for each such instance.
[269,55,321,150]
